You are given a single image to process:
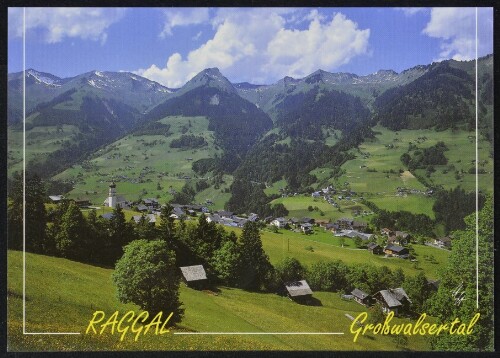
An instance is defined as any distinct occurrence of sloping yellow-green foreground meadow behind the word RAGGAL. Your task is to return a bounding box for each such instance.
[7,251,436,351]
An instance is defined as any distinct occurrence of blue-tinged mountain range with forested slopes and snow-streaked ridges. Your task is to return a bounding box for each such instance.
[7,55,493,213]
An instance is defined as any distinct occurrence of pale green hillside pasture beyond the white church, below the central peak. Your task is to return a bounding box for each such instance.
[51,116,232,208]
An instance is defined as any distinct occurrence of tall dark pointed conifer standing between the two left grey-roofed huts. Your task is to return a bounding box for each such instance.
[239,221,272,290]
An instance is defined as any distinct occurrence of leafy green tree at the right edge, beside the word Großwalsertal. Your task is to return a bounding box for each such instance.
[429,196,494,351]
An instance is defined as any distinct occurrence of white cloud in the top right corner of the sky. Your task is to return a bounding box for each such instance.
[422,8,493,61]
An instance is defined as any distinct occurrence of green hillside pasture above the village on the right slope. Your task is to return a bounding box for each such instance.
[311,126,493,218]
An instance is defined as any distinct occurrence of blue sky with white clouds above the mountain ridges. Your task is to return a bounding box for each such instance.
[8,7,493,88]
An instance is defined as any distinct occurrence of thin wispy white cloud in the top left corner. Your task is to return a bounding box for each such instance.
[8,7,125,43]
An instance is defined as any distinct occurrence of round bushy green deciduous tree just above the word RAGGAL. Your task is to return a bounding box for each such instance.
[113,240,184,323]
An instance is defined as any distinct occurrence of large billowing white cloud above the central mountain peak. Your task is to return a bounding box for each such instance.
[136,8,370,87]
